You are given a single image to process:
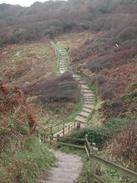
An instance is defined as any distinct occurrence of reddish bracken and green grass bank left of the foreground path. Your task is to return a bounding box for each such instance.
[0,83,54,183]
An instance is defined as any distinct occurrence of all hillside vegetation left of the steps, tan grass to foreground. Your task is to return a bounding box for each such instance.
[0,40,80,183]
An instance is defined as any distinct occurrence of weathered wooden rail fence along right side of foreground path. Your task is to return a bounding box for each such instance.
[56,137,137,183]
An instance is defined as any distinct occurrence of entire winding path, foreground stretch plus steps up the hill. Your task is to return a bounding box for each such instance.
[38,41,95,183]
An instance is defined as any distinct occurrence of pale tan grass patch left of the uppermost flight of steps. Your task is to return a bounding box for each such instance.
[0,41,56,86]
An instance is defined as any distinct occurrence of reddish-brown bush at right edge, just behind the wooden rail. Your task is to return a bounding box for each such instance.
[111,122,137,169]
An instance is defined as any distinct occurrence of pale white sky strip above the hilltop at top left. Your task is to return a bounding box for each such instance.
[0,0,47,6]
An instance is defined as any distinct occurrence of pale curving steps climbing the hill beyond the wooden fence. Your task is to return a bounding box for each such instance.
[54,44,95,136]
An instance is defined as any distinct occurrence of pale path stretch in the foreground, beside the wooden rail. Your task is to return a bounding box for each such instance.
[37,151,82,183]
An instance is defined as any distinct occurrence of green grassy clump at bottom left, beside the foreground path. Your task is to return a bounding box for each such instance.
[0,136,55,183]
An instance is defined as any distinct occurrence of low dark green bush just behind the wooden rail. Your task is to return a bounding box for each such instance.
[70,118,128,149]
